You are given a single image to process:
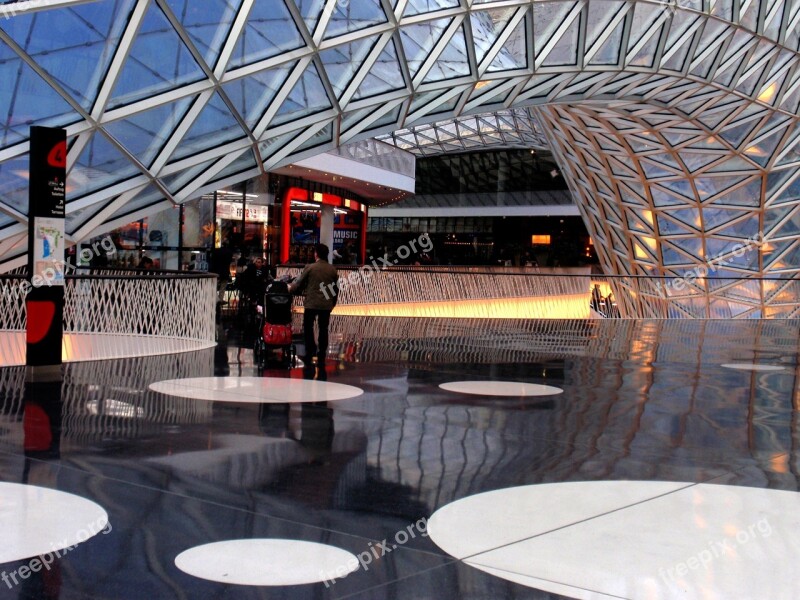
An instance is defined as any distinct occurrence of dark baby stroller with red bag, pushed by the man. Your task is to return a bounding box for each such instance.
[253,280,297,370]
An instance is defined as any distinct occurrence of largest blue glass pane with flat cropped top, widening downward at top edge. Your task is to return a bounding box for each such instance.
[228,0,304,70]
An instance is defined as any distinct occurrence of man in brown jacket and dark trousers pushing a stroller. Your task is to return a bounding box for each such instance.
[289,244,339,367]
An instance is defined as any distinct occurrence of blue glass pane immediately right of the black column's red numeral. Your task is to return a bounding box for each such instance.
[69,132,141,199]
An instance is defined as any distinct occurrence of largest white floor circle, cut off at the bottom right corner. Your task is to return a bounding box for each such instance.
[428,481,800,599]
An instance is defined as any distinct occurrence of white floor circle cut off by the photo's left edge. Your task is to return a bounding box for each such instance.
[0,482,108,564]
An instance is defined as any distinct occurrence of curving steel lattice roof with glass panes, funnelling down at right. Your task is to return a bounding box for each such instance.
[0,0,800,316]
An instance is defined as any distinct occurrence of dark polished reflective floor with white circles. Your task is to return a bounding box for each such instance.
[0,317,800,600]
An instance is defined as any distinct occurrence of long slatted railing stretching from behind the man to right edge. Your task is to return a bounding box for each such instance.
[272,266,800,319]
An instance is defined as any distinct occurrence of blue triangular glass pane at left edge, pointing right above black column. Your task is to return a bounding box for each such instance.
[0,45,80,146]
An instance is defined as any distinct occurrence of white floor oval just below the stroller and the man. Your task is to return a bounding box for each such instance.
[150,377,364,404]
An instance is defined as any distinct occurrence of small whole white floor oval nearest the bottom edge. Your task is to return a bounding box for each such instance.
[175,539,358,585]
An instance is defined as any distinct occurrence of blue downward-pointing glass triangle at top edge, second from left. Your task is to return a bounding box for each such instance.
[163,0,239,69]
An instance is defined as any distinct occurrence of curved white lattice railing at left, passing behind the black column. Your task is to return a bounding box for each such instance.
[0,269,217,366]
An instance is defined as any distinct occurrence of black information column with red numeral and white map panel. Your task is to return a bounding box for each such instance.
[26,127,67,371]
